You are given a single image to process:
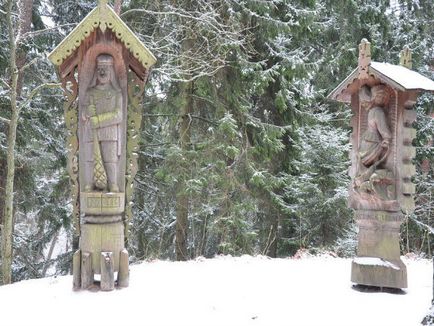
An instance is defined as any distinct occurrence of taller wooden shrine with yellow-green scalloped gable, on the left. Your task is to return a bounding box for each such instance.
[49,0,156,290]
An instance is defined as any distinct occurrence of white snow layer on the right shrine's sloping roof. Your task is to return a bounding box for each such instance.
[369,61,434,92]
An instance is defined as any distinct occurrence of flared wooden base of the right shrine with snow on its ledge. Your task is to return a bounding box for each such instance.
[351,210,407,288]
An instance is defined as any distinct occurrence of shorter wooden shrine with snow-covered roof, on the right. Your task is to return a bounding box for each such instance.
[328,39,434,288]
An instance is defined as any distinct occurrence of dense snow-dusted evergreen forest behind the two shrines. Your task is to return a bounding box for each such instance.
[0,0,434,281]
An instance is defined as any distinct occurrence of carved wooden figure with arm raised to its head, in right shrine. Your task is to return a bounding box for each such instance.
[354,85,394,200]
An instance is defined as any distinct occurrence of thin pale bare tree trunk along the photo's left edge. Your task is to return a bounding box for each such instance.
[1,0,19,284]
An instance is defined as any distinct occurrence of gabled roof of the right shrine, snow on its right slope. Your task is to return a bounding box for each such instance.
[327,61,434,103]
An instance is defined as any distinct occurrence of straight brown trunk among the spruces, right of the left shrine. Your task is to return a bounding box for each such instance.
[175,82,193,260]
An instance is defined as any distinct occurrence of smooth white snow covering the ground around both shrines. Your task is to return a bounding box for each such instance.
[0,256,433,326]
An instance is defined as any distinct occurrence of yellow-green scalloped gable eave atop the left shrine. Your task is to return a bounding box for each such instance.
[48,1,157,69]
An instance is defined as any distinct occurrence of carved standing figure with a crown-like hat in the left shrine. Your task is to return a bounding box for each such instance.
[82,54,123,192]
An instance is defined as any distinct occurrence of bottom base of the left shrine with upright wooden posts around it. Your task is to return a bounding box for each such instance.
[73,222,129,291]
